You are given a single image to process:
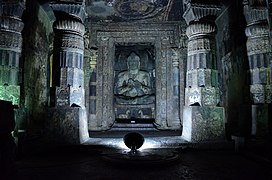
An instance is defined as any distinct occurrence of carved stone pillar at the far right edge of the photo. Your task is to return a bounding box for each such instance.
[244,2,272,137]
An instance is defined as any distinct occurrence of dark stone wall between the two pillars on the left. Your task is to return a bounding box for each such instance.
[18,0,53,135]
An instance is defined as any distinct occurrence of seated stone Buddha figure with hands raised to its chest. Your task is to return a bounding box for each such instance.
[115,52,155,104]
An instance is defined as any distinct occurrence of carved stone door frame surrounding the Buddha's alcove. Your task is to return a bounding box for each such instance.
[89,23,184,130]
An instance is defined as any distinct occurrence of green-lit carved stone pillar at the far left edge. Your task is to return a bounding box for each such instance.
[0,0,25,105]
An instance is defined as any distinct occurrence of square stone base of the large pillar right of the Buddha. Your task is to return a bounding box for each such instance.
[182,106,225,142]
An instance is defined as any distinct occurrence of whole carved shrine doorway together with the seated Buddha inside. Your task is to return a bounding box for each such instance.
[86,23,186,131]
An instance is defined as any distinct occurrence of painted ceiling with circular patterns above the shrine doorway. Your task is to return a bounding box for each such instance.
[86,0,183,22]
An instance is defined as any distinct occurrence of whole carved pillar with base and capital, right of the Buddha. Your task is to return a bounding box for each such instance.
[182,3,225,142]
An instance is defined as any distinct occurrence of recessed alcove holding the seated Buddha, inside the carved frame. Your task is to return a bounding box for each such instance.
[114,43,156,123]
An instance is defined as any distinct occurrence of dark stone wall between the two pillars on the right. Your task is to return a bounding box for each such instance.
[216,1,251,137]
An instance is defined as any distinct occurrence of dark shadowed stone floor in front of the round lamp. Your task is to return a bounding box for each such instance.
[3,139,272,180]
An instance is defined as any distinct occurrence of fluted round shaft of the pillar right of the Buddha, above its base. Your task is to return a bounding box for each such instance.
[185,22,219,106]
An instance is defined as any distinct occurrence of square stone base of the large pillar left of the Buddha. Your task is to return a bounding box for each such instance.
[46,107,89,145]
